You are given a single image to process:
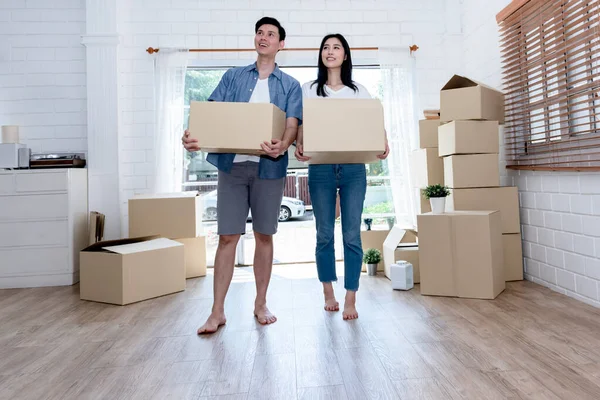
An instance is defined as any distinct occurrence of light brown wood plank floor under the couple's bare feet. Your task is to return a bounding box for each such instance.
[0,264,600,400]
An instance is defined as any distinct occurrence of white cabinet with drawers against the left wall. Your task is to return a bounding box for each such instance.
[0,168,89,289]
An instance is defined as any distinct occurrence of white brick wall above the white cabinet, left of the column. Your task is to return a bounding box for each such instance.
[0,0,87,152]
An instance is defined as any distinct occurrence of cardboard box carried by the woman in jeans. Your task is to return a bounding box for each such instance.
[302,98,385,164]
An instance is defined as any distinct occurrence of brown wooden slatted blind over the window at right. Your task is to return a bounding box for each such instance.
[497,0,600,170]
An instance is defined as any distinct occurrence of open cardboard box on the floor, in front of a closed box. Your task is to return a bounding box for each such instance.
[80,236,185,305]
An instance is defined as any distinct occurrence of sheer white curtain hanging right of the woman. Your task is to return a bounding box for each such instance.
[378,47,419,228]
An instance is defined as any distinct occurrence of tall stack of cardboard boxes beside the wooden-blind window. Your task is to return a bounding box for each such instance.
[417,76,523,299]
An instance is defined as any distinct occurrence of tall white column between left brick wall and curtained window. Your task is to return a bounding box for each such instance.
[82,0,121,239]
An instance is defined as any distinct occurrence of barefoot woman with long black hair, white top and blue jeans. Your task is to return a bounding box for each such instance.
[296,34,389,320]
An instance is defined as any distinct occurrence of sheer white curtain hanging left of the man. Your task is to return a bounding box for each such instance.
[150,48,188,193]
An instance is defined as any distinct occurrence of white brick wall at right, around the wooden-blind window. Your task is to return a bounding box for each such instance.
[462,0,600,307]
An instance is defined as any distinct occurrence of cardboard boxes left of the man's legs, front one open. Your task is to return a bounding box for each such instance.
[80,192,206,305]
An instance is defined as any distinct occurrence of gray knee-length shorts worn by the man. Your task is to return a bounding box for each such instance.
[217,161,285,235]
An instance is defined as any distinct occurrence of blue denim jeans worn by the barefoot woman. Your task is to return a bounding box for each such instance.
[308,164,367,291]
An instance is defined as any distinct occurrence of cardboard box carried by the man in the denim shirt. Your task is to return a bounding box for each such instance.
[188,101,286,155]
